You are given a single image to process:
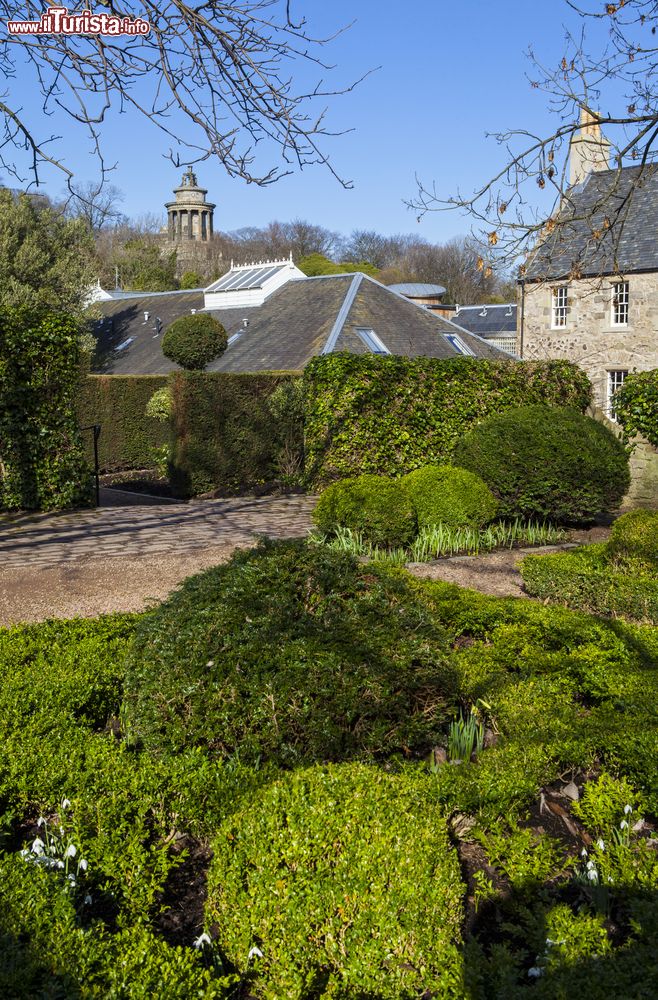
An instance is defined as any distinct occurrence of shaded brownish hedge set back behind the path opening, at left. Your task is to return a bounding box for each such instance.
[78,375,169,472]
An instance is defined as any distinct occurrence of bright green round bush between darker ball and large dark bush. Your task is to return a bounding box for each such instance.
[400,465,498,528]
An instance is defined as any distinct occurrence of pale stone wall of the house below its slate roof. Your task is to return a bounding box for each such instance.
[517,274,658,410]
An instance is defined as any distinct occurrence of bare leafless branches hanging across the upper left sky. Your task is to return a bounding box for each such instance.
[0,0,364,186]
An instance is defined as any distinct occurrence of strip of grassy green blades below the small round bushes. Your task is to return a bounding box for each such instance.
[310,518,569,566]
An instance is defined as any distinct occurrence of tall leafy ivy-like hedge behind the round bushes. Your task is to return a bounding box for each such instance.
[304,353,591,486]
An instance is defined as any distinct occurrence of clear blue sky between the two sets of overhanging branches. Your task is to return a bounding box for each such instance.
[5,0,608,241]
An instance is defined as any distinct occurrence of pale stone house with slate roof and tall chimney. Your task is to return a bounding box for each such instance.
[516,114,658,503]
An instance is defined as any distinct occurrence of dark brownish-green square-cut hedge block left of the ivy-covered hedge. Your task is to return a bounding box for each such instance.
[171,372,303,496]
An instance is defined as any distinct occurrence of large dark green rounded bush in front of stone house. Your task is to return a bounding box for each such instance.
[455,406,630,522]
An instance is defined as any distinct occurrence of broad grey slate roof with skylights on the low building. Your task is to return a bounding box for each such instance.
[92,274,509,375]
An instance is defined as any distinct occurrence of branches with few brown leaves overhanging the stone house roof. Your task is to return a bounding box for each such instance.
[409,0,658,269]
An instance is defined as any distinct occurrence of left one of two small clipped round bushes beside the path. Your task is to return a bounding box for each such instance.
[313,475,417,548]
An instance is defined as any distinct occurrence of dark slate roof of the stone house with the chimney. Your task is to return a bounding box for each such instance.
[525,165,658,281]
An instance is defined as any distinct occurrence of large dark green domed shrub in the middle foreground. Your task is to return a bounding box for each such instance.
[124,542,452,765]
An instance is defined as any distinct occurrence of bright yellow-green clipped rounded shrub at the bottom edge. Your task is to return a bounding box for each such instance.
[206,764,465,1000]
